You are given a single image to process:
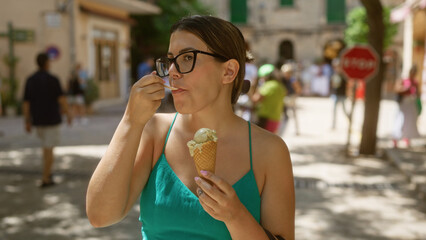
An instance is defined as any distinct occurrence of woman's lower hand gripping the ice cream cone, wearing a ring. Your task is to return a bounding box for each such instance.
[195,171,245,223]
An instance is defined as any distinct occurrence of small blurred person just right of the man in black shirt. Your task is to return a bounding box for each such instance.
[68,64,89,125]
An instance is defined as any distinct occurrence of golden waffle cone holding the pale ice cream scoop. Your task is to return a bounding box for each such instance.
[194,141,217,176]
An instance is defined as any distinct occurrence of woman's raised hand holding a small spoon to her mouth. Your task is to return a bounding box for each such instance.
[124,71,165,124]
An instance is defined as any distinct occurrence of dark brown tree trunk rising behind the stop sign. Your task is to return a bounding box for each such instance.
[359,0,385,155]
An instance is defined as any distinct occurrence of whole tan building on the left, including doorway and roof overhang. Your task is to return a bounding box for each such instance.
[0,0,161,110]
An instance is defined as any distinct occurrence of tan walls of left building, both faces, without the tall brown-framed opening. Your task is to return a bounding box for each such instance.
[0,0,136,105]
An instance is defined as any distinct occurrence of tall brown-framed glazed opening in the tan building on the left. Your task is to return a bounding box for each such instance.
[94,30,117,81]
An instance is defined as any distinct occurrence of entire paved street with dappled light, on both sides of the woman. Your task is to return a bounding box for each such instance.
[0,98,426,240]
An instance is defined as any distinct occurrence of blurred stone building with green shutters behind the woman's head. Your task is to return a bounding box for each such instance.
[203,0,359,64]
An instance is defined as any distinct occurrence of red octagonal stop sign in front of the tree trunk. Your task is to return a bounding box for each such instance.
[341,46,379,80]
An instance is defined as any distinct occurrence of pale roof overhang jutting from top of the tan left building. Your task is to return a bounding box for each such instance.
[90,0,161,14]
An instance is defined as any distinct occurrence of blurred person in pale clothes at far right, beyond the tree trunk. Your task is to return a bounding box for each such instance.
[393,65,421,147]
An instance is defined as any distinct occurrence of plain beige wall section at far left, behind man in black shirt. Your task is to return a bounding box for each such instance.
[0,0,69,97]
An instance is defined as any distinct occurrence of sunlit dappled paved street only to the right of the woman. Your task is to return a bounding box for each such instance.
[284,98,426,239]
